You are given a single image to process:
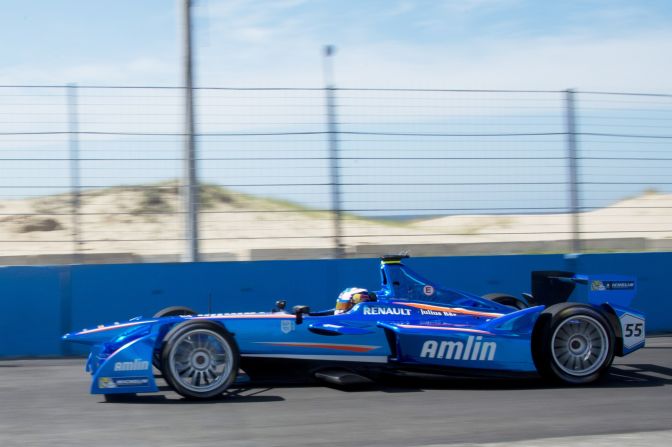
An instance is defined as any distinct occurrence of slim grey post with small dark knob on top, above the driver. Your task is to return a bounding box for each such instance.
[324,45,345,258]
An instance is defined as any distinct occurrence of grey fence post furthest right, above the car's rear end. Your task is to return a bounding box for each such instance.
[565,89,581,253]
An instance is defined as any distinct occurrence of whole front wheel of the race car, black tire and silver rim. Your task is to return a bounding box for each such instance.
[161,320,240,399]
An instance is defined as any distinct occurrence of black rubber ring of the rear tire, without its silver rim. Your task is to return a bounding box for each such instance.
[532,303,615,385]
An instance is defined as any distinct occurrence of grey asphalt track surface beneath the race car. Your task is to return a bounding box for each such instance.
[0,337,672,447]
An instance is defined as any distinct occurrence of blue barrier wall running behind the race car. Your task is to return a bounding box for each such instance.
[0,253,672,357]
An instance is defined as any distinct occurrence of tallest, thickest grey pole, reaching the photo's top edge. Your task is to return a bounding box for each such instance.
[182,0,199,262]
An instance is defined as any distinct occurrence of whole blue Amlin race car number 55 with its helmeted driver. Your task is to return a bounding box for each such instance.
[63,256,645,399]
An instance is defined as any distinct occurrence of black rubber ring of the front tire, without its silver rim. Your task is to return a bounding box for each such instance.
[161,320,240,399]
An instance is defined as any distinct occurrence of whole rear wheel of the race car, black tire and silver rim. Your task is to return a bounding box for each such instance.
[532,303,615,385]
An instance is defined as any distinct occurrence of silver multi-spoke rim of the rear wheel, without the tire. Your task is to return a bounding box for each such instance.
[551,315,609,376]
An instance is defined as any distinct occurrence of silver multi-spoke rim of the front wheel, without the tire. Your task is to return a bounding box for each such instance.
[169,329,233,393]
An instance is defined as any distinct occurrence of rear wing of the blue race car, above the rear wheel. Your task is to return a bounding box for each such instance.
[532,271,637,307]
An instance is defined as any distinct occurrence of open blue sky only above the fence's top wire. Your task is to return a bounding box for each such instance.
[0,0,672,92]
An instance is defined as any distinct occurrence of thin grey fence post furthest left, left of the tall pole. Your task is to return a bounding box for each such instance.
[67,84,83,263]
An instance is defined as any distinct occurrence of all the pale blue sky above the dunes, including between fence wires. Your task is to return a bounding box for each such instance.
[0,0,672,214]
